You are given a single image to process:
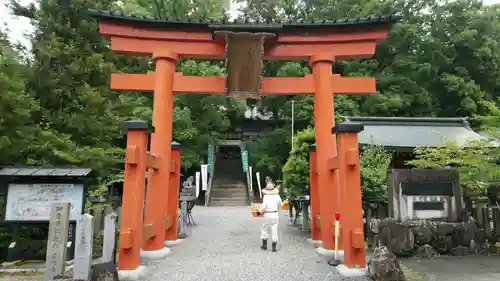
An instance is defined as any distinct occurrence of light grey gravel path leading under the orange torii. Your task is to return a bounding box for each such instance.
[143,206,368,281]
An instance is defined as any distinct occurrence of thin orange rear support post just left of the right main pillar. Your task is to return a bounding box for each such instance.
[309,144,321,241]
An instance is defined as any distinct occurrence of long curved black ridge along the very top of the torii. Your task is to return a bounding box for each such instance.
[87,9,401,28]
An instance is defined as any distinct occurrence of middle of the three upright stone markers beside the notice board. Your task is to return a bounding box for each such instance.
[73,214,94,281]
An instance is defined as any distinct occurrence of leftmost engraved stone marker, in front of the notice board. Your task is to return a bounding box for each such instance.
[44,203,71,281]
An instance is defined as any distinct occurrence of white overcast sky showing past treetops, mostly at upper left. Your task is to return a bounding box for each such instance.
[0,0,500,46]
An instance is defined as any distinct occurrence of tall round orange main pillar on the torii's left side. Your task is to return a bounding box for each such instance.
[142,50,178,253]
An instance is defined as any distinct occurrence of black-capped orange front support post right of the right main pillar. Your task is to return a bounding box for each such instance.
[332,123,366,269]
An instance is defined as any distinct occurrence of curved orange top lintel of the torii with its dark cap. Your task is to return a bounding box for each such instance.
[89,10,399,60]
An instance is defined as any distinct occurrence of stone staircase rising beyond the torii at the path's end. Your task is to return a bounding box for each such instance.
[209,156,248,206]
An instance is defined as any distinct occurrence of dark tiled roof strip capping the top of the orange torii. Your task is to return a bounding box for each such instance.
[88,9,400,30]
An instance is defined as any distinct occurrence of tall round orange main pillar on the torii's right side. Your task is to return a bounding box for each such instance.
[310,53,339,250]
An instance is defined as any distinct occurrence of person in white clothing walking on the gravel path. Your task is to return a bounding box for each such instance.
[259,181,282,252]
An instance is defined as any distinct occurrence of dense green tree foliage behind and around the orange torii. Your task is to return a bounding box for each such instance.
[0,0,500,196]
